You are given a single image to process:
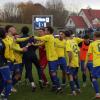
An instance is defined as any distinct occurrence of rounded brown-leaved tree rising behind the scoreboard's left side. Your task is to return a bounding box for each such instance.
[18,1,46,23]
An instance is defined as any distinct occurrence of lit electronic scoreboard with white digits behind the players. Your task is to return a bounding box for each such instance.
[32,15,53,30]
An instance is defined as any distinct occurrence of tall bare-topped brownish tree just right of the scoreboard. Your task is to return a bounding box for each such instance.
[46,0,68,27]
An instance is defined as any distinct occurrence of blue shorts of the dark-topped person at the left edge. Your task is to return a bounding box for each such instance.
[0,66,11,81]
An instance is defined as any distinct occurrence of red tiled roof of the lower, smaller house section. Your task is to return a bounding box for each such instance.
[70,16,87,28]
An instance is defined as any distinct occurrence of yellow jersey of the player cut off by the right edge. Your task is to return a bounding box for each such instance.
[88,40,100,67]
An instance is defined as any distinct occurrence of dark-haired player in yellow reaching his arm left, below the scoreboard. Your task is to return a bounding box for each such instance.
[35,27,62,92]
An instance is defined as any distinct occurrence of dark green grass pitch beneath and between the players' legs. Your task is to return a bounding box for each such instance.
[10,67,95,100]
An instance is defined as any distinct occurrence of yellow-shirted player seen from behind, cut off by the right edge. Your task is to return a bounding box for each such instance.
[84,32,100,98]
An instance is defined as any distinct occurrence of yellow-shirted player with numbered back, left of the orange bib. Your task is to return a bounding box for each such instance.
[65,31,80,96]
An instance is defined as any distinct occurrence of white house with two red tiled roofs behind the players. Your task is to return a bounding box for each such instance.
[65,9,100,32]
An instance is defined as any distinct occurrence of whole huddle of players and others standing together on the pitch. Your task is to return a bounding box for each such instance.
[0,25,100,100]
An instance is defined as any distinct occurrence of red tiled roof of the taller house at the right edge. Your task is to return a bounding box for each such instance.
[81,9,100,24]
